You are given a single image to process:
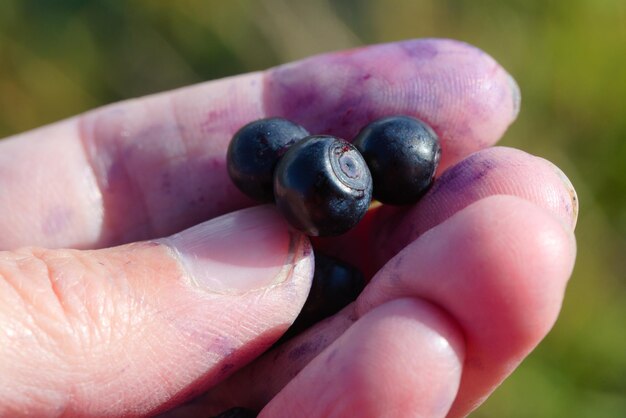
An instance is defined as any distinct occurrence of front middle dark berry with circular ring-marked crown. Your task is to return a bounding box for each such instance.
[274,135,372,236]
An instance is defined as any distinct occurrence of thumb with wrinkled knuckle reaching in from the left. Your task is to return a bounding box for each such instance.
[0,206,313,417]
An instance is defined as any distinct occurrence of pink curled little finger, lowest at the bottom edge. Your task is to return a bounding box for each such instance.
[260,299,463,417]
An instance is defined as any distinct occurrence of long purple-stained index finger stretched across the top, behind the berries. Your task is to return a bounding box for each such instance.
[0,40,519,248]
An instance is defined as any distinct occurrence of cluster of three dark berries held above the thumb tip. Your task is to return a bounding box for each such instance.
[227,116,441,236]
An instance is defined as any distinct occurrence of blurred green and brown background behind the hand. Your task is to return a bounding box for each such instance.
[0,0,626,418]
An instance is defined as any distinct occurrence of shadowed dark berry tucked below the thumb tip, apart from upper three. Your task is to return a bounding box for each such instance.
[280,252,365,342]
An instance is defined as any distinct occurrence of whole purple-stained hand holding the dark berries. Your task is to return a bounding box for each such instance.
[0,40,577,417]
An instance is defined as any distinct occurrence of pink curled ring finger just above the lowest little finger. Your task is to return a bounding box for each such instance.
[356,196,576,417]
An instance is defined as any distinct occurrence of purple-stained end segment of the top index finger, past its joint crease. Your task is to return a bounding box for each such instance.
[265,40,518,166]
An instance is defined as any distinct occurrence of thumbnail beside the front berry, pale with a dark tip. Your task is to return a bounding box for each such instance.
[160,205,302,294]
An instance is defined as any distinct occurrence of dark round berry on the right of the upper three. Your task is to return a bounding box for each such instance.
[353,116,441,205]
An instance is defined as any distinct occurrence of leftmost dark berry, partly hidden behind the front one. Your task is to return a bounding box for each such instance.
[226,118,309,202]
